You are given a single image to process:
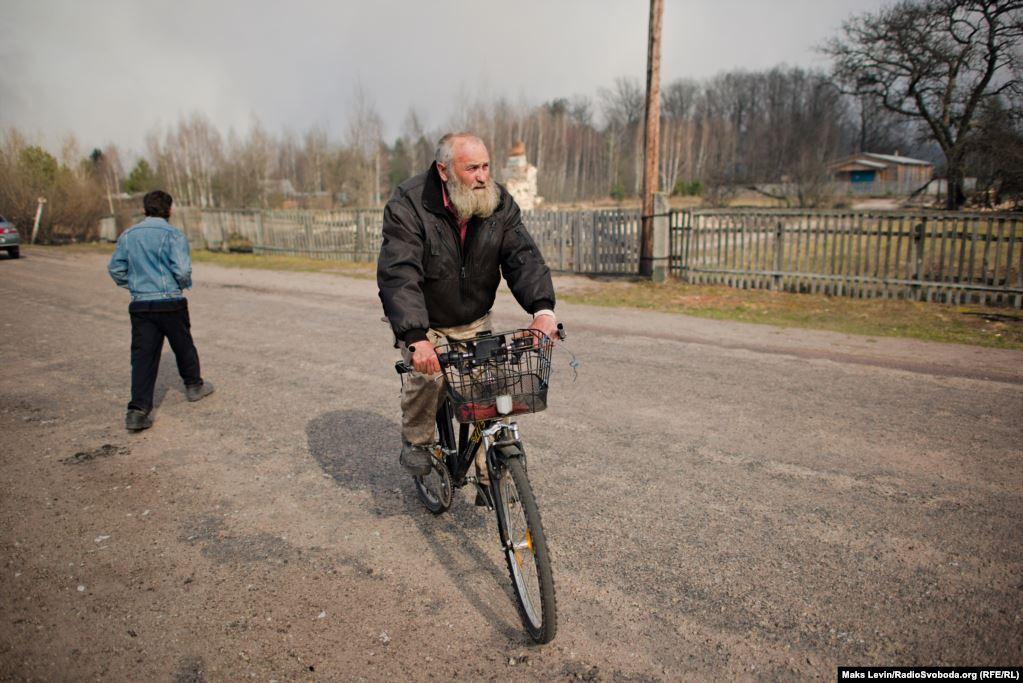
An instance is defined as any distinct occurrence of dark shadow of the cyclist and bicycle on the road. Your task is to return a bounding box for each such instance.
[306,410,531,644]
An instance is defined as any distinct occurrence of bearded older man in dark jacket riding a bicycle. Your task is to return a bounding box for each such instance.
[376,133,558,481]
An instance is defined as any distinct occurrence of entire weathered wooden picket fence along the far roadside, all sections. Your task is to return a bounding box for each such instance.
[175,204,1023,308]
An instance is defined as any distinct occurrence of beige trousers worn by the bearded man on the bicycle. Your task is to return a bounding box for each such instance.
[399,313,492,476]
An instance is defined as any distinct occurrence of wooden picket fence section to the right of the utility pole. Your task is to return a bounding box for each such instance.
[671,210,1023,308]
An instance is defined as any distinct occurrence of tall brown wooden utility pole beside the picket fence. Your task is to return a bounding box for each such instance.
[639,0,664,277]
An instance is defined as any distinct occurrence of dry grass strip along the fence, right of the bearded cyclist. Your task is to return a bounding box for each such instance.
[559,282,1023,349]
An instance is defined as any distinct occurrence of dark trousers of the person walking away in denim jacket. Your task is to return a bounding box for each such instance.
[128,299,203,413]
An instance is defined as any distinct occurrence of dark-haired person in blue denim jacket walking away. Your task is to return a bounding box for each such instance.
[107,190,213,431]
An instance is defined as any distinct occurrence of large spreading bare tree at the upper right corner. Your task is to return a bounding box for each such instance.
[822,0,1023,209]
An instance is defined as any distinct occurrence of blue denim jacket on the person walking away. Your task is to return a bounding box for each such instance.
[106,216,191,302]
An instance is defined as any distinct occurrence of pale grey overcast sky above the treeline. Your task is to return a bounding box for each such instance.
[0,0,884,157]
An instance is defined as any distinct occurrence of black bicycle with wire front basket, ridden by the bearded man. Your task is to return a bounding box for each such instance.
[395,324,565,643]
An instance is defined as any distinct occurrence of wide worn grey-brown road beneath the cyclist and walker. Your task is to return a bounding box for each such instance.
[0,249,1023,681]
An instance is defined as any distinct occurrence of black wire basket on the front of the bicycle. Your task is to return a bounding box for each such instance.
[437,329,553,422]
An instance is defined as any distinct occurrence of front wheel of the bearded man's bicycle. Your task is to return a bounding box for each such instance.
[494,457,558,643]
